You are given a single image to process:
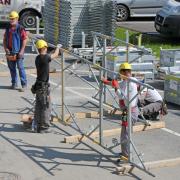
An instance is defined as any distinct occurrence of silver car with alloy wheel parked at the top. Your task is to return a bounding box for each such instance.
[115,0,168,21]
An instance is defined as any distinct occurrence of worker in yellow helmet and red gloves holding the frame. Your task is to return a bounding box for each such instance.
[102,62,139,161]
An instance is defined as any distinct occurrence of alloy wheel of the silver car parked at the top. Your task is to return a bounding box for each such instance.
[116,5,129,21]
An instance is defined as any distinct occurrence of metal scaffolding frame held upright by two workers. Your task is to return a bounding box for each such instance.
[27,32,155,177]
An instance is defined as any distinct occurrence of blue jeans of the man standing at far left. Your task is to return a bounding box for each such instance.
[7,58,27,86]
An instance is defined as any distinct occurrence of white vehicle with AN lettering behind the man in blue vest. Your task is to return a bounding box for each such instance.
[0,0,45,28]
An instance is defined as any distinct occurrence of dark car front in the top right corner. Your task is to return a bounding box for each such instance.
[154,0,180,37]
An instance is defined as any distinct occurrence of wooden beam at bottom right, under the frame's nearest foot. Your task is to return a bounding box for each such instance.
[116,157,180,174]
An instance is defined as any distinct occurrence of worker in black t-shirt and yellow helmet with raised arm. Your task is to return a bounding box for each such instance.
[31,39,61,133]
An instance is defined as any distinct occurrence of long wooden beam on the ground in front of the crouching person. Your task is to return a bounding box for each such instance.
[64,121,165,143]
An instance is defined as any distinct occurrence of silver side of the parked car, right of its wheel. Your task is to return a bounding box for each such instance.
[131,0,167,16]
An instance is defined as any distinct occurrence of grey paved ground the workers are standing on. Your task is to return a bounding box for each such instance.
[0,27,180,180]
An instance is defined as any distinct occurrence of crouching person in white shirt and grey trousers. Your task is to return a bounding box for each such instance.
[138,87,167,120]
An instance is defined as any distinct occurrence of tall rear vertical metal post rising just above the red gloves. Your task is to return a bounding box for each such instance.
[102,38,107,103]
